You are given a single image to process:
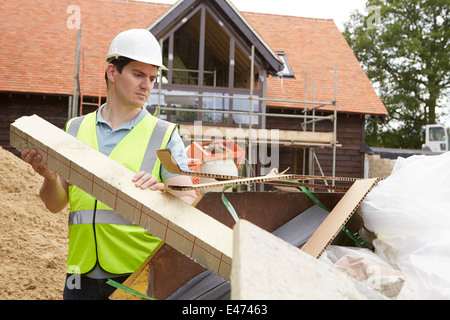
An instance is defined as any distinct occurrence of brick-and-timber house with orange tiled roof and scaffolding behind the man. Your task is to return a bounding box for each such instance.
[0,0,387,184]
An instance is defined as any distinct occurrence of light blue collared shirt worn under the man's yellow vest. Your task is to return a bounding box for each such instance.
[96,105,189,181]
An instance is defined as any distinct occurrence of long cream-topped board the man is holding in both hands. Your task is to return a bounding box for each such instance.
[10,115,233,280]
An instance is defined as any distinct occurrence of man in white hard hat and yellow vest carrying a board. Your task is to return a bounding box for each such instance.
[22,29,196,299]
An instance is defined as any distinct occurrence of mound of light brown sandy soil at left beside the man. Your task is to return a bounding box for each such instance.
[0,147,68,300]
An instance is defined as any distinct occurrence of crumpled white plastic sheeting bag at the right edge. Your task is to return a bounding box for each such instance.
[361,152,450,299]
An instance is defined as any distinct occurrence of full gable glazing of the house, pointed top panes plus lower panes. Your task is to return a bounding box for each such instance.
[156,2,262,126]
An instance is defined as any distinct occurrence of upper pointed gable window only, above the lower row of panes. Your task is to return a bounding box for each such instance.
[163,4,259,89]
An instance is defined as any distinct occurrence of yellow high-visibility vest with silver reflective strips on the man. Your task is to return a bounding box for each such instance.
[66,112,177,274]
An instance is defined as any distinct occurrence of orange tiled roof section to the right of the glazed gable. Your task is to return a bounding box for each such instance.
[243,12,387,115]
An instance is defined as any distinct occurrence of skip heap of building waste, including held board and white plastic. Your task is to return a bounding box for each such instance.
[7,116,450,300]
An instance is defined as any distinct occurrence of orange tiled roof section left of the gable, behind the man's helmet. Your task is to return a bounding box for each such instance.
[0,0,170,96]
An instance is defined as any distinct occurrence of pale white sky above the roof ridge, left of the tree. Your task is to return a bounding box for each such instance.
[144,0,367,31]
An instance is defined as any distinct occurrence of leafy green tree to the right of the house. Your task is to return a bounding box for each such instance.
[344,0,450,148]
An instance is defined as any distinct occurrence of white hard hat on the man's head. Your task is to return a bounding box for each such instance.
[105,29,168,70]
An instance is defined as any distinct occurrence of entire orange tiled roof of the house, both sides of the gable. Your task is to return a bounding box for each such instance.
[0,0,387,114]
